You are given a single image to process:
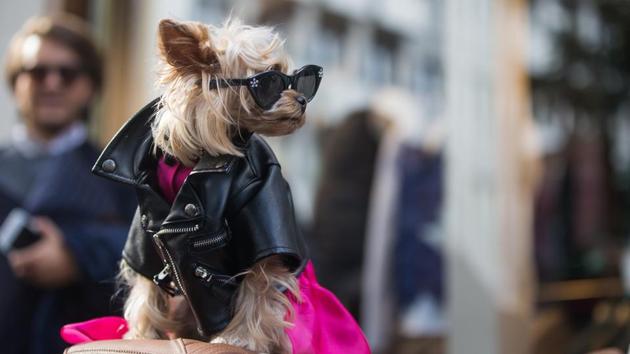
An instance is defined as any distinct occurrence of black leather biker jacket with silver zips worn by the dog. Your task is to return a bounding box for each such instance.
[92,101,306,336]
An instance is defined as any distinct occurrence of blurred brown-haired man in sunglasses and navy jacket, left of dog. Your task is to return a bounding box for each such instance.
[0,14,135,354]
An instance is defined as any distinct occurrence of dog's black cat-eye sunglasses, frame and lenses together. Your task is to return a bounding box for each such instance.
[210,65,324,110]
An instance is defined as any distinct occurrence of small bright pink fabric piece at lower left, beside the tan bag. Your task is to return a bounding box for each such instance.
[60,316,128,344]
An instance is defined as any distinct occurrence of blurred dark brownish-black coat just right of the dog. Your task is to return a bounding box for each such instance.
[310,110,380,320]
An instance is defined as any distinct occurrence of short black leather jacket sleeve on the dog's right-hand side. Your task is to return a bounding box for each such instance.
[227,164,307,271]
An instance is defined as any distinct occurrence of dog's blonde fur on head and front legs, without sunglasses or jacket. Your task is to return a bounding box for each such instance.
[121,20,304,353]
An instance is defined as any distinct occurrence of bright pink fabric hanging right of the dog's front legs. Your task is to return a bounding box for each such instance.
[286,262,370,354]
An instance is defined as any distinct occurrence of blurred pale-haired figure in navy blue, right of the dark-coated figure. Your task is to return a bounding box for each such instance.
[361,88,446,353]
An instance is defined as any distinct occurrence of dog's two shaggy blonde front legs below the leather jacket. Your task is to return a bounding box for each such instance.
[120,256,300,353]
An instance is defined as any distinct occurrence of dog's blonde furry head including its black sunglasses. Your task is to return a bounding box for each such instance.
[153,20,321,164]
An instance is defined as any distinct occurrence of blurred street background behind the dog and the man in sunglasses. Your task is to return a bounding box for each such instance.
[0,0,630,354]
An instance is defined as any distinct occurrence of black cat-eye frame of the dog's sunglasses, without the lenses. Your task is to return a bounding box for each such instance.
[209,64,324,110]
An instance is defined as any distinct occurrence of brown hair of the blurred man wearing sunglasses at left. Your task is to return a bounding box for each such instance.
[4,13,103,91]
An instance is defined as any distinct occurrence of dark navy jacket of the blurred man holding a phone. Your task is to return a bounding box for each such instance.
[0,138,136,354]
